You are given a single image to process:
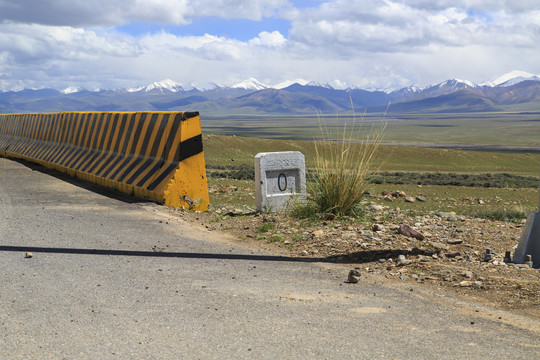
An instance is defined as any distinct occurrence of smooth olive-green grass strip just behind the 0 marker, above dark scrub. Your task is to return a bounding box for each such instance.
[203,134,540,176]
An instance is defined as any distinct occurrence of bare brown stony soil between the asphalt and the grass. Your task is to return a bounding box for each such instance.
[169,188,540,320]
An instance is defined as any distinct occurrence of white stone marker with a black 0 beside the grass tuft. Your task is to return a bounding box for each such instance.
[255,151,306,211]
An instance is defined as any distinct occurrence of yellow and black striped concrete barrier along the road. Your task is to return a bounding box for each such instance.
[0,112,209,211]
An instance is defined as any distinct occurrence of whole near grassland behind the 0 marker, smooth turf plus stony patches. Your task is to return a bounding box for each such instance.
[203,129,540,221]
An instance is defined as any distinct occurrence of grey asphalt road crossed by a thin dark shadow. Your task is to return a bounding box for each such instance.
[0,158,540,359]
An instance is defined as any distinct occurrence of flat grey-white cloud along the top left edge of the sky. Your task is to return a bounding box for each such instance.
[0,0,291,27]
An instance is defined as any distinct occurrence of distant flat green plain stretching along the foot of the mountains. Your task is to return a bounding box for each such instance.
[202,112,540,146]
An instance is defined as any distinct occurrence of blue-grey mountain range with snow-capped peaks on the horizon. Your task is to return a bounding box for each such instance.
[0,71,540,117]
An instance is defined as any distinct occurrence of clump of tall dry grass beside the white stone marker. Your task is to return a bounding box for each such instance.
[308,105,386,216]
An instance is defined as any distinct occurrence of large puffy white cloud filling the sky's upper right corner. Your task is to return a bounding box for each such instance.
[290,0,540,56]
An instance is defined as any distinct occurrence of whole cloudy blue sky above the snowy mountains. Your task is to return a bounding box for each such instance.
[0,0,540,91]
